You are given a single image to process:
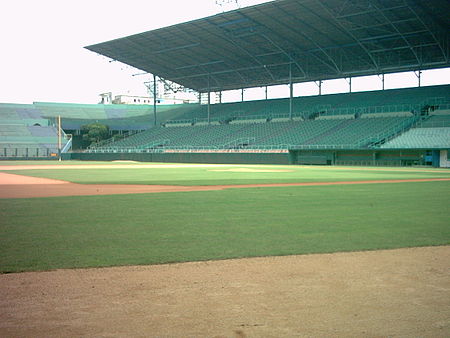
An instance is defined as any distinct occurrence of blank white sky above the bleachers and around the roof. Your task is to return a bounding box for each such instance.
[0,0,450,103]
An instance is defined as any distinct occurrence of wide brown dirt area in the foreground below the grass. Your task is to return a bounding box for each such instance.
[0,246,450,337]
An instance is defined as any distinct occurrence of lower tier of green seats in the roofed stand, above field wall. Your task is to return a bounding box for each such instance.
[93,117,413,151]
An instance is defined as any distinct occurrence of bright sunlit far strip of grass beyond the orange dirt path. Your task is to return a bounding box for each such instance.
[3,165,450,185]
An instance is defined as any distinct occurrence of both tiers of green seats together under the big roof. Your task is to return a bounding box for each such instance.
[92,86,450,151]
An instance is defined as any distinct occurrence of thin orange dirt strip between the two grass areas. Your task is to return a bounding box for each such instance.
[0,172,450,198]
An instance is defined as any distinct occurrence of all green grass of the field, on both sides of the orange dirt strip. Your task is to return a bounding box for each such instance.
[0,163,450,272]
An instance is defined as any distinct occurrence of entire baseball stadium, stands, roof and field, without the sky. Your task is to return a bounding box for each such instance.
[0,0,450,337]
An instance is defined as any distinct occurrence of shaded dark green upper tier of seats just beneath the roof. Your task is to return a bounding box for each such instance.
[170,85,450,123]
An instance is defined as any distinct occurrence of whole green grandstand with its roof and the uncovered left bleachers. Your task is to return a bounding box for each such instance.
[0,0,450,167]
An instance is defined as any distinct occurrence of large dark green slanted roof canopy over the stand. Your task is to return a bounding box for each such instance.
[86,0,450,92]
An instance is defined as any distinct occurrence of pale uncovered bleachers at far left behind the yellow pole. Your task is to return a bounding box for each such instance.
[0,102,198,157]
